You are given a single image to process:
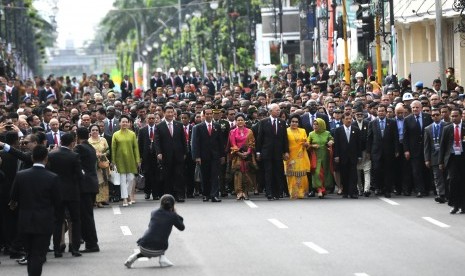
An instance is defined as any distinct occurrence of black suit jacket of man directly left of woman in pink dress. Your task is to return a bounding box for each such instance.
[192,122,225,162]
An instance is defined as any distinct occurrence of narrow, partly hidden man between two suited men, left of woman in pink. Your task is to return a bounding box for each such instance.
[181,112,195,198]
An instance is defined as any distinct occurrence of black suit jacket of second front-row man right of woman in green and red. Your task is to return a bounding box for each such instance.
[367,118,399,161]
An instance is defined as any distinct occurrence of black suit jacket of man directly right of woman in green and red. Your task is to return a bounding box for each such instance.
[334,126,362,166]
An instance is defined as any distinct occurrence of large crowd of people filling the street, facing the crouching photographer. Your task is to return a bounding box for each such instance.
[0,64,465,274]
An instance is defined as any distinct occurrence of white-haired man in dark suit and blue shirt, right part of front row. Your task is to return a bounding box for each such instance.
[403,100,433,197]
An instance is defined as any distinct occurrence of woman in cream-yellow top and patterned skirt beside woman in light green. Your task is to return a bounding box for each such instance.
[88,125,110,208]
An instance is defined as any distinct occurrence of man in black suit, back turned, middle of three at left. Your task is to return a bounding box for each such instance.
[47,133,83,258]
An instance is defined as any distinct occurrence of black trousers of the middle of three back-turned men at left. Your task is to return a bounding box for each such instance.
[53,200,80,251]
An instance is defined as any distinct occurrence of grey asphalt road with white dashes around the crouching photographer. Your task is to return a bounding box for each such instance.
[0,194,465,276]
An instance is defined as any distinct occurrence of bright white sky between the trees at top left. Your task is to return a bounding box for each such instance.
[34,0,114,49]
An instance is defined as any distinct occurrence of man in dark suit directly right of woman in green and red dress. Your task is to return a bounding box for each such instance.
[334,112,362,198]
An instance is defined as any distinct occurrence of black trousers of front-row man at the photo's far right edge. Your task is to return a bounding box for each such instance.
[447,153,465,208]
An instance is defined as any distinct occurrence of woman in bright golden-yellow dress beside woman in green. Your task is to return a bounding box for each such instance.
[284,114,310,199]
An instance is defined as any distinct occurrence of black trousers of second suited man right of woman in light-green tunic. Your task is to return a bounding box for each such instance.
[163,160,186,198]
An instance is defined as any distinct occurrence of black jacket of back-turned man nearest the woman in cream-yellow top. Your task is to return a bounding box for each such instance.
[74,141,98,194]
